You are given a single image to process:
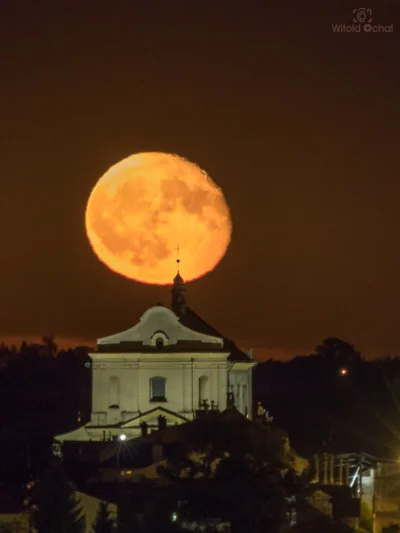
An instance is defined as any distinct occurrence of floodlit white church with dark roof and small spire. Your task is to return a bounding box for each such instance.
[56,272,257,442]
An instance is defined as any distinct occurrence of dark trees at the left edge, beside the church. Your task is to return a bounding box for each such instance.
[0,337,91,480]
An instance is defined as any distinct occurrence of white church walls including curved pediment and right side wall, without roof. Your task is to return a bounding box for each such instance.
[91,306,256,425]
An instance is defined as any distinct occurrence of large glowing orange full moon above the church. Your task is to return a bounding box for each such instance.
[85,152,232,285]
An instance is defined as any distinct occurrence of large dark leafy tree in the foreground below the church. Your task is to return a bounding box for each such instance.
[156,415,299,533]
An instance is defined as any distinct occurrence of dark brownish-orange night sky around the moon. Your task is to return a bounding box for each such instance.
[0,0,400,357]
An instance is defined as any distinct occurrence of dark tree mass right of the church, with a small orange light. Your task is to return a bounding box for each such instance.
[254,338,400,457]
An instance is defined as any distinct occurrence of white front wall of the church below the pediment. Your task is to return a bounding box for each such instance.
[92,354,229,425]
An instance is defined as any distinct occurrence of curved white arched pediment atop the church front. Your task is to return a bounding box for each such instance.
[97,306,223,347]
